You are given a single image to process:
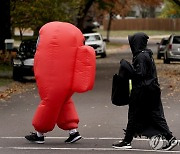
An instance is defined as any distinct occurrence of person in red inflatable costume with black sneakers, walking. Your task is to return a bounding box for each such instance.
[25,21,96,143]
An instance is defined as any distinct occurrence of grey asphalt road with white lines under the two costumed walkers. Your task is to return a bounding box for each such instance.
[0,45,180,154]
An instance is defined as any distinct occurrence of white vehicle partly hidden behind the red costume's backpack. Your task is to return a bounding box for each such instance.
[84,33,106,58]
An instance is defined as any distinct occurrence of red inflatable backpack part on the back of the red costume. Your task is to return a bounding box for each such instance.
[72,46,96,93]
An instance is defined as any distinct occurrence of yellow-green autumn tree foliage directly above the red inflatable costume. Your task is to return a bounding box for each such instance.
[11,0,79,39]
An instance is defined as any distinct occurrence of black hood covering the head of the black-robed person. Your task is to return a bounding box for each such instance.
[128,32,149,56]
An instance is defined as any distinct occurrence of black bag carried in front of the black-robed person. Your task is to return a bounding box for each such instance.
[111,74,129,106]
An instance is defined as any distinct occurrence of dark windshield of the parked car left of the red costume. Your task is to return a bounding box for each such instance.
[18,40,36,58]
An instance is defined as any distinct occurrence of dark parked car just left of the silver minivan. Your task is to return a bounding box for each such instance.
[157,38,168,59]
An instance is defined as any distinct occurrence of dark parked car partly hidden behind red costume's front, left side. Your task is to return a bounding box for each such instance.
[12,40,37,81]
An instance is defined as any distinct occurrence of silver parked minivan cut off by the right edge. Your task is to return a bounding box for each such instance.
[164,35,180,64]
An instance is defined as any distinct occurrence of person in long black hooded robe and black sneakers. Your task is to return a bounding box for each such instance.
[113,32,177,150]
